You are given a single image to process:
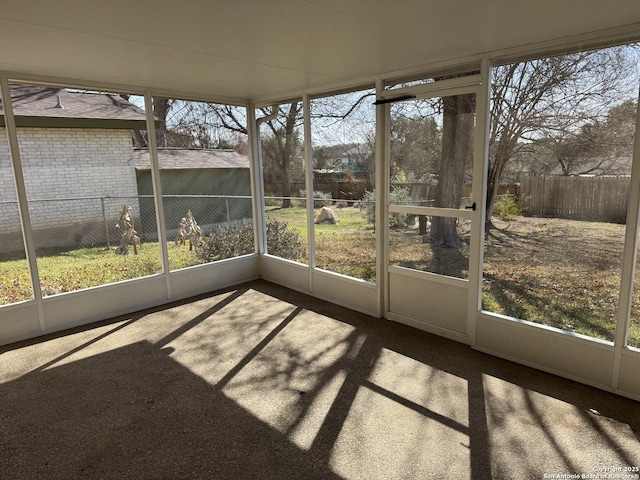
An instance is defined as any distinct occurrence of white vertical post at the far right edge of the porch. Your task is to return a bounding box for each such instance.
[611,82,640,389]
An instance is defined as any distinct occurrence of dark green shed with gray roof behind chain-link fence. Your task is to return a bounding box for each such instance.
[133,148,252,238]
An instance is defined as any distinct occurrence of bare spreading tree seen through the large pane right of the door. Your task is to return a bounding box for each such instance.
[486,47,633,227]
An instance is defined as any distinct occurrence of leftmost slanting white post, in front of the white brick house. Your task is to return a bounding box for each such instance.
[0,77,46,332]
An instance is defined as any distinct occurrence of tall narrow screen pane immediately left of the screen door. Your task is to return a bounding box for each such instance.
[311,89,376,282]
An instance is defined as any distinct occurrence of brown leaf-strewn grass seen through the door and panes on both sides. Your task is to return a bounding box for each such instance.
[308,213,640,347]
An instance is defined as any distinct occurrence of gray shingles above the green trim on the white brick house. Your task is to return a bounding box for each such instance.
[0,85,146,121]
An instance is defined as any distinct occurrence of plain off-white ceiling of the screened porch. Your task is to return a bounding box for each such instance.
[0,0,640,99]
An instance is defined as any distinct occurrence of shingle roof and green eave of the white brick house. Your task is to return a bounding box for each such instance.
[0,85,146,129]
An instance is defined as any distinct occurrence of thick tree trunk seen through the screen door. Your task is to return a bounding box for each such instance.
[431,94,475,248]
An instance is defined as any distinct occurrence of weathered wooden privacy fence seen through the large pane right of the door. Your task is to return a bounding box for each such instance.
[519,176,631,223]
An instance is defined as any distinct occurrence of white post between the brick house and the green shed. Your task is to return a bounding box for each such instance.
[144,91,172,300]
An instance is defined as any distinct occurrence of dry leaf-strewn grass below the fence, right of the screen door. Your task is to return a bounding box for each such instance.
[483,217,640,345]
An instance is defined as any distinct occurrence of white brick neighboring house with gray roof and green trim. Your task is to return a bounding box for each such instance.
[0,85,146,253]
